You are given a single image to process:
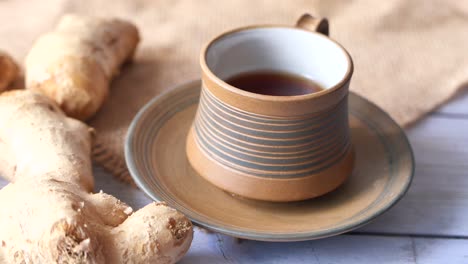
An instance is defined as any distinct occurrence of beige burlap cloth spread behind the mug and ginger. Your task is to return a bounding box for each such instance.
[0,0,468,182]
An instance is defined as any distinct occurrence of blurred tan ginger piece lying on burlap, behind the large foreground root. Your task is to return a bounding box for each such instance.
[25,15,139,120]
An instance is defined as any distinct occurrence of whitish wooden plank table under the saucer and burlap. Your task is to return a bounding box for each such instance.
[0,92,468,264]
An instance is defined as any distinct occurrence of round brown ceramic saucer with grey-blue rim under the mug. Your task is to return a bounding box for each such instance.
[125,81,414,241]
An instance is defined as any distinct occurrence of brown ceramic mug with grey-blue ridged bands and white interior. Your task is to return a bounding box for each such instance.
[186,15,354,201]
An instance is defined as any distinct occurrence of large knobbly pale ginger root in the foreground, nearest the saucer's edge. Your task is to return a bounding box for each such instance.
[0,90,193,264]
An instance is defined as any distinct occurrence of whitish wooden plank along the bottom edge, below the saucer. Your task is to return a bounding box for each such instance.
[180,229,468,264]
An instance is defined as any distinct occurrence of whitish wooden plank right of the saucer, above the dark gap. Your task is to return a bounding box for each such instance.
[360,115,468,237]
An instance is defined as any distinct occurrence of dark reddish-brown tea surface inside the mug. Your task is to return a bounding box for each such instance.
[226,71,323,96]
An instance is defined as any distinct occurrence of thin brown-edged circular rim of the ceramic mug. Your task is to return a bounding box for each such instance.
[200,25,354,102]
